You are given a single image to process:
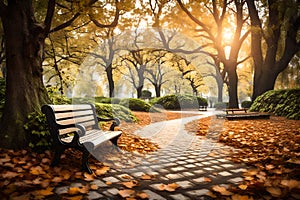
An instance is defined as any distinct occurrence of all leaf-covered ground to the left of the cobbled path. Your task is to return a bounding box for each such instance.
[0,112,195,200]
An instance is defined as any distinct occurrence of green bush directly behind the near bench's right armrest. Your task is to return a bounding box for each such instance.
[95,103,137,122]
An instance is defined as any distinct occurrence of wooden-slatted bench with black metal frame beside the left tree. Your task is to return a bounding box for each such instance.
[42,104,122,174]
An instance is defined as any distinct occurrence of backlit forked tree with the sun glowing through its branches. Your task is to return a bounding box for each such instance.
[177,0,249,108]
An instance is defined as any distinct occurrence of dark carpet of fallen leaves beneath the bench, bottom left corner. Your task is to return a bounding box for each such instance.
[0,149,109,199]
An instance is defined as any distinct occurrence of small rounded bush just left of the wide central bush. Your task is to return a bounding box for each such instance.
[120,98,157,112]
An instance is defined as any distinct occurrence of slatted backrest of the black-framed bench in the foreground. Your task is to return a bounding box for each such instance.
[42,104,99,141]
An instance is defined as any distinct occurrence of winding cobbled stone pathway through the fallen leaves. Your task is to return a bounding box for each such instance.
[55,112,251,200]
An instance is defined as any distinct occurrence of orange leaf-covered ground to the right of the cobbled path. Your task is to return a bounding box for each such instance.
[186,116,300,199]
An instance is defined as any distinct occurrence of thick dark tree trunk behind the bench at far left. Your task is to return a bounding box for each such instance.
[0,1,50,149]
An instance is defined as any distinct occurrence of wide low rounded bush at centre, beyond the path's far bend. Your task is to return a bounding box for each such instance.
[150,94,208,109]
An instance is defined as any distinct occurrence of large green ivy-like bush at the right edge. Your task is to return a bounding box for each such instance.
[250,89,300,120]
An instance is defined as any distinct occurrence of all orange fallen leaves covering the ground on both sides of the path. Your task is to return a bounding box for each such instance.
[0,112,300,200]
